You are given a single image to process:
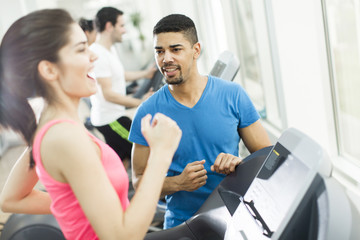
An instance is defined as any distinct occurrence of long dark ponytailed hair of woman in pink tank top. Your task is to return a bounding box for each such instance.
[0,9,74,166]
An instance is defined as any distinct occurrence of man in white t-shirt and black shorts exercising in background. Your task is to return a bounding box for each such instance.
[90,7,156,168]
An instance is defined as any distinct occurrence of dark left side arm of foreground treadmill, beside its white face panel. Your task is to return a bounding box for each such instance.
[145,147,271,240]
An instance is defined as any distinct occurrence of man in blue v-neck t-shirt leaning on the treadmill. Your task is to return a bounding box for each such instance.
[129,14,271,229]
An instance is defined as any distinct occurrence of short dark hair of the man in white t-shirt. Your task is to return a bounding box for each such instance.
[95,7,124,32]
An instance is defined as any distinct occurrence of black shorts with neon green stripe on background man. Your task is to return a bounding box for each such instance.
[96,116,132,160]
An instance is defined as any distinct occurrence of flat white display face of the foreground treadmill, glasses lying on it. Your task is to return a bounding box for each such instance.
[229,143,310,239]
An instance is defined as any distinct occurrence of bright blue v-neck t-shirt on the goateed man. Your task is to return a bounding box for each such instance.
[129,76,259,229]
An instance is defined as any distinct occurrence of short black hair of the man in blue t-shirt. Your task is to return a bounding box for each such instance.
[153,14,198,44]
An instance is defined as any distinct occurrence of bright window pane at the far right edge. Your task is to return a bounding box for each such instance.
[323,0,360,163]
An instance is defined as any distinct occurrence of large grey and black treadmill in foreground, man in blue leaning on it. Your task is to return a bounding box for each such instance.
[145,128,360,240]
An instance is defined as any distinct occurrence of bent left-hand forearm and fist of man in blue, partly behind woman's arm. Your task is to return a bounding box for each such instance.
[132,143,207,197]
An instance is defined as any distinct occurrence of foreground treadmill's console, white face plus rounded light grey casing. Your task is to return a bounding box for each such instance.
[225,129,331,240]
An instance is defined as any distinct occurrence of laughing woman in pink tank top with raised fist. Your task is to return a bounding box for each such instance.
[0,9,181,239]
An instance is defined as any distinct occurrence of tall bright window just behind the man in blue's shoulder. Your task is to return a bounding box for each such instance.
[227,0,287,130]
